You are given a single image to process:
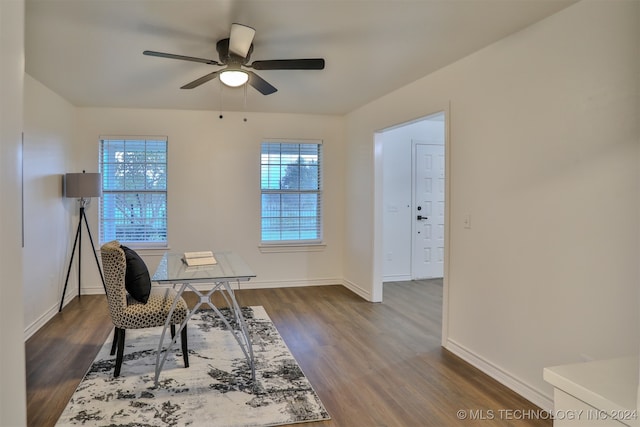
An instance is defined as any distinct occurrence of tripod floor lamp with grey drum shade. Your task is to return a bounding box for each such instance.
[58,171,107,312]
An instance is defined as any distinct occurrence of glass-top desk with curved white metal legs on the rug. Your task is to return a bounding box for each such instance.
[151,252,256,384]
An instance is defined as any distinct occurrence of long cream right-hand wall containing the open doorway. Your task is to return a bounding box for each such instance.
[345,1,640,409]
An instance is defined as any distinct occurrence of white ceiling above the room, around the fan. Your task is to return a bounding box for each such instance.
[23,0,576,114]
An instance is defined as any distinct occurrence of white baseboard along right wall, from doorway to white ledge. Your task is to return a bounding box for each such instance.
[444,339,553,412]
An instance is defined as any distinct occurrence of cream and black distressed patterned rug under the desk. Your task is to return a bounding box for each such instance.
[56,307,330,427]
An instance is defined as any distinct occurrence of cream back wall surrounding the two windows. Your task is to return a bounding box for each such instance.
[71,108,345,293]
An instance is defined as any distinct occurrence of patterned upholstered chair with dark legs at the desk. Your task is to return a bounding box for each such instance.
[100,240,189,377]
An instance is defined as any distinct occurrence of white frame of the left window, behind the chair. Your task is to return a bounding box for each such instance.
[98,135,169,249]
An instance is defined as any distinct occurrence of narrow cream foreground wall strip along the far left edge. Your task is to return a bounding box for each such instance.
[0,0,27,427]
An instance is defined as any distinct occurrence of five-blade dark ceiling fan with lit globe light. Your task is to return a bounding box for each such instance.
[142,23,324,95]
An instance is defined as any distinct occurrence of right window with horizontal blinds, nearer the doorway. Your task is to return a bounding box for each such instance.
[260,141,322,243]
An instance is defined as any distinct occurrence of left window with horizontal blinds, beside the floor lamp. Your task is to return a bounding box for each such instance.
[100,137,167,246]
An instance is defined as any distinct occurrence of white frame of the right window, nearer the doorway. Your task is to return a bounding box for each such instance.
[259,138,325,247]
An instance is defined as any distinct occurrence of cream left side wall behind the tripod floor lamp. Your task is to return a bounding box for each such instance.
[23,75,79,336]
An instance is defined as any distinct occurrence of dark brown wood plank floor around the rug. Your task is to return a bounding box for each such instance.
[26,280,551,427]
